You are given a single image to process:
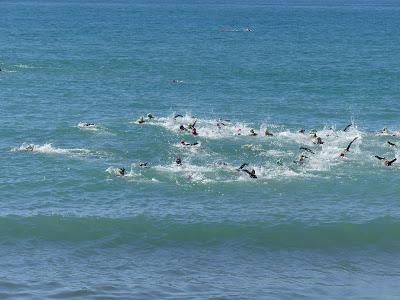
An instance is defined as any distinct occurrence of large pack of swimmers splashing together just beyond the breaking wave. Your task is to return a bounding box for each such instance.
[24,113,397,179]
